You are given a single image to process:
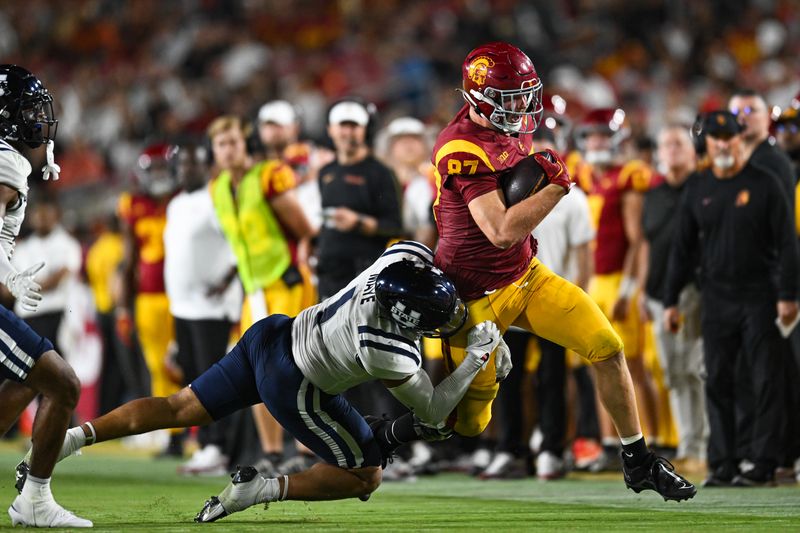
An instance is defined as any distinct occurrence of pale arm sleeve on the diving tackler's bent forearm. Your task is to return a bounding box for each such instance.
[389,365,480,426]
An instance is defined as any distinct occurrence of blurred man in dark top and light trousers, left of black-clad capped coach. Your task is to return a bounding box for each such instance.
[638,125,708,471]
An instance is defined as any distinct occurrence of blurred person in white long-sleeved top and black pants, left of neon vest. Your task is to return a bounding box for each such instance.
[164,143,242,475]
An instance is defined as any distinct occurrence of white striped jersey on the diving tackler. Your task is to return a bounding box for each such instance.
[292,241,433,394]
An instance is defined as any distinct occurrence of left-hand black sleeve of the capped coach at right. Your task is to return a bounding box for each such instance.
[664,177,698,307]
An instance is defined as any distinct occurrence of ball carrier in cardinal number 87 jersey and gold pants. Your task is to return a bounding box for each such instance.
[432,42,697,500]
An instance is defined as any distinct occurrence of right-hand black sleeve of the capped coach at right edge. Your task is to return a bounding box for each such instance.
[769,179,798,300]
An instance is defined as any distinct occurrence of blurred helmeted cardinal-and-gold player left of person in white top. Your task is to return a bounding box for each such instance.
[116,142,183,457]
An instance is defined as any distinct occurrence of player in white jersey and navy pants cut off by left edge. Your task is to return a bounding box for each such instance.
[0,65,92,527]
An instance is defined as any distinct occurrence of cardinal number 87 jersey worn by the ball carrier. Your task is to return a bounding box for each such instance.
[432,105,534,300]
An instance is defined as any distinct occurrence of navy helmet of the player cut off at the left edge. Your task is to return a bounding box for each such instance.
[0,65,58,148]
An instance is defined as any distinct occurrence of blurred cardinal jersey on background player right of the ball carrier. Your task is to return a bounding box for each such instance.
[589,160,652,274]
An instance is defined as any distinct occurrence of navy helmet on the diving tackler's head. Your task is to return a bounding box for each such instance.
[375,260,467,338]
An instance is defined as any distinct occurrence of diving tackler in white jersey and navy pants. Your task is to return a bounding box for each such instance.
[18,241,511,522]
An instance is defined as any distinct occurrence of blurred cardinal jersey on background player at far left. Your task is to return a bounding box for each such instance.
[118,193,168,293]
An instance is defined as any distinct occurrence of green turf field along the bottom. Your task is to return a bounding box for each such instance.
[0,443,800,533]
